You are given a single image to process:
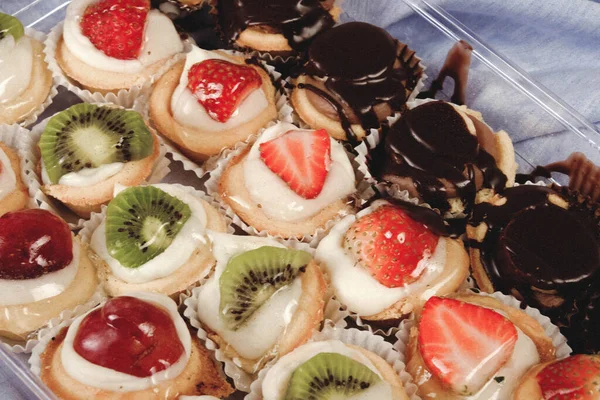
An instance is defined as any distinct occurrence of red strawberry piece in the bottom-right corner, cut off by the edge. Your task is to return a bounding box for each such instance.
[537,354,600,400]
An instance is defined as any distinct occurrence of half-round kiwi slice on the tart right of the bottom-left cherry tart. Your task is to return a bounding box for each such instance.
[219,246,312,330]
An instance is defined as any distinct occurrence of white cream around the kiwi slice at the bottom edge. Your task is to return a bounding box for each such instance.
[262,340,392,400]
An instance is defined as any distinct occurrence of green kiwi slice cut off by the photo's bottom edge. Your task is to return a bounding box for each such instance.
[284,353,381,400]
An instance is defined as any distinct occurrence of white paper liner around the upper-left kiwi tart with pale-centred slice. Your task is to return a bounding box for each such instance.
[20,104,170,229]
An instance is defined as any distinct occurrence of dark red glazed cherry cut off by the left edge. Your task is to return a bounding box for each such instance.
[0,210,73,279]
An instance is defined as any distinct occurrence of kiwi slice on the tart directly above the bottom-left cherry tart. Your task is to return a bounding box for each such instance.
[106,186,192,268]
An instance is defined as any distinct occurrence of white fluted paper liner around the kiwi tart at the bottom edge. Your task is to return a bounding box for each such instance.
[244,327,420,400]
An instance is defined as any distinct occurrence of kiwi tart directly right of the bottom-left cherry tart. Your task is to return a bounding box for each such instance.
[185,233,326,374]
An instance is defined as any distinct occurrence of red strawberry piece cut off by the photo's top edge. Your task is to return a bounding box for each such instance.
[81,0,150,60]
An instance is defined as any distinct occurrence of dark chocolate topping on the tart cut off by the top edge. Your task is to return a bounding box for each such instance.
[219,0,335,51]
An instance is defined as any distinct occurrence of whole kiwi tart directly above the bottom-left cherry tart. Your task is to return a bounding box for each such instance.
[88,183,227,296]
